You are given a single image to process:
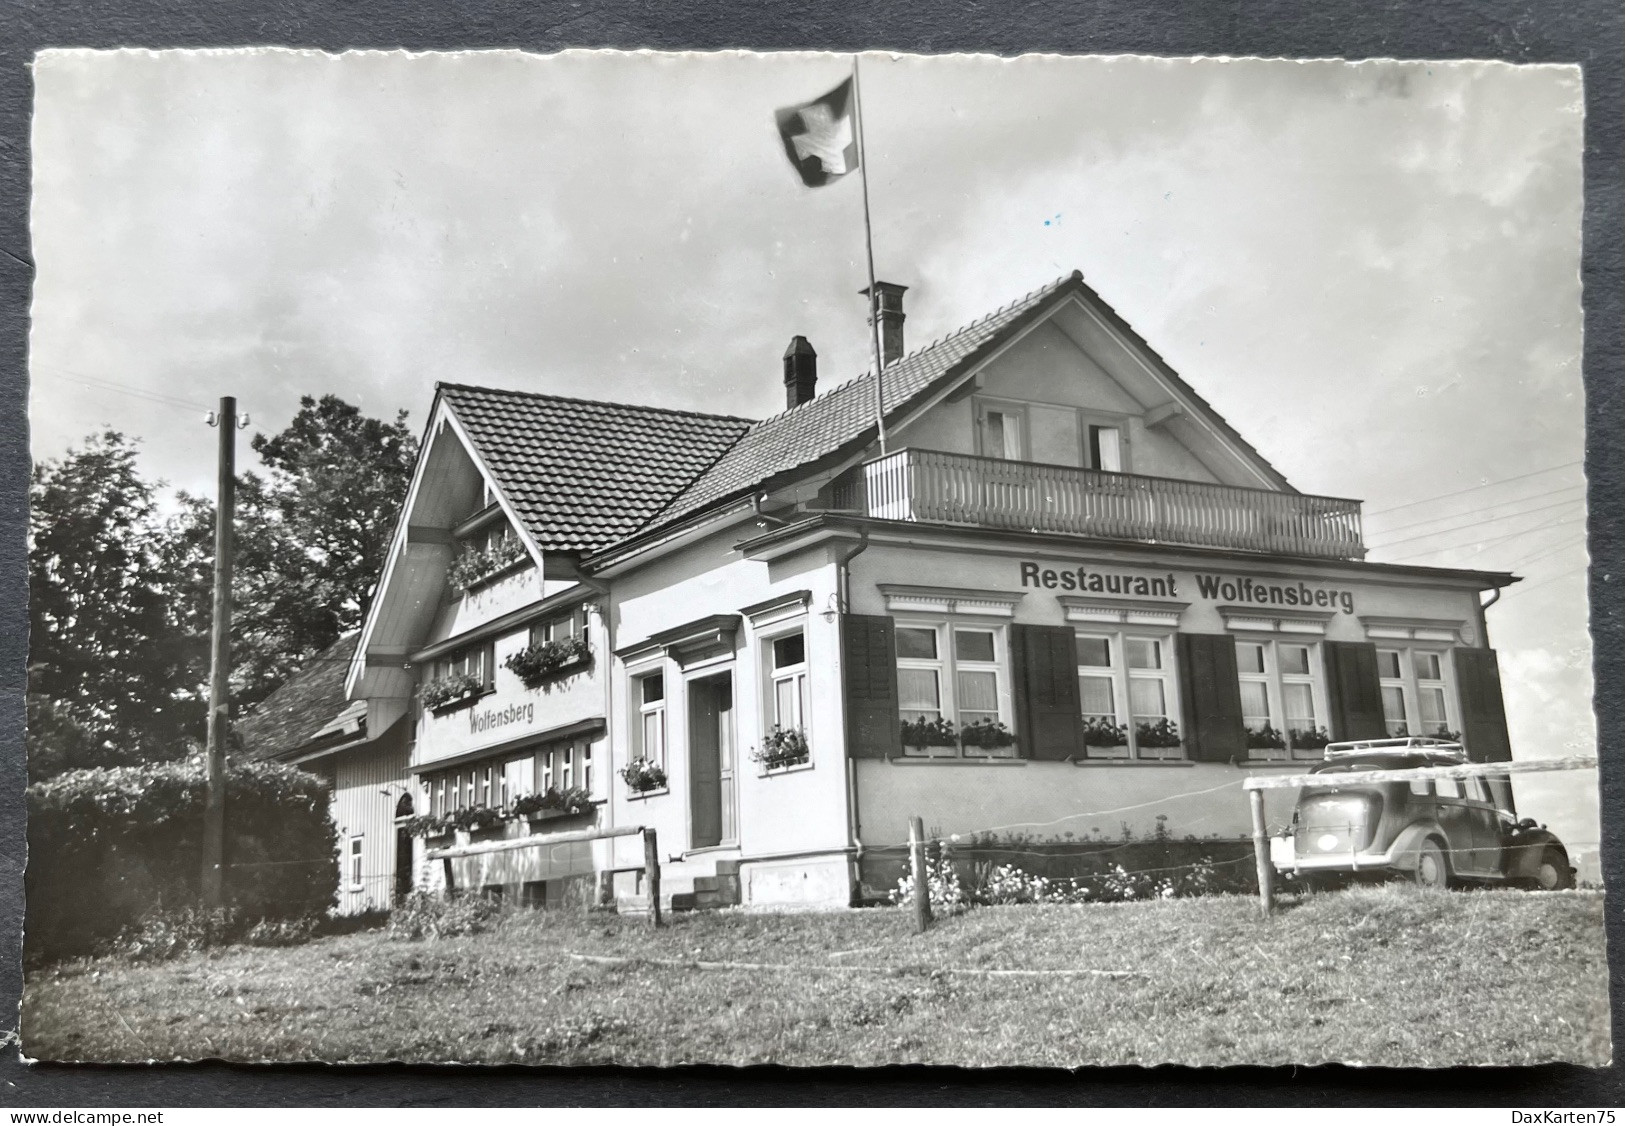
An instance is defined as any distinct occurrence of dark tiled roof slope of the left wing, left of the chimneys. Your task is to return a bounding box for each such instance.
[439,383,751,551]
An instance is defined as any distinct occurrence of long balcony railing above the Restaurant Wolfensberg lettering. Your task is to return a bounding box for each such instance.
[830,450,1365,559]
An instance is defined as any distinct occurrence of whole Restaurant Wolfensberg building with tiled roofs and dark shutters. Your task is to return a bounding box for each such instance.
[346,273,1516,907]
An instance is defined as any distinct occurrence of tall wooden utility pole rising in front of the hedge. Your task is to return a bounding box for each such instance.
[202,395,247,907]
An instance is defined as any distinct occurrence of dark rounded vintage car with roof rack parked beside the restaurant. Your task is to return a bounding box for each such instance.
[1271,738,1575,890]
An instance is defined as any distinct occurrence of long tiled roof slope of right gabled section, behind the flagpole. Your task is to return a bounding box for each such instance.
[650,271,1084,526]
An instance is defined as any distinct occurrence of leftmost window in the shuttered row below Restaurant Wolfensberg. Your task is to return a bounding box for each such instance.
[897,622,1016,757]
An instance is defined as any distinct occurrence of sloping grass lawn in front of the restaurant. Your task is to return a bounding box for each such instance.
[23,886,1610,1066]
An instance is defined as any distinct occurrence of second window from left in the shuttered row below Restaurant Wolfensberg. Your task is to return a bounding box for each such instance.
[1077,632,1185,759]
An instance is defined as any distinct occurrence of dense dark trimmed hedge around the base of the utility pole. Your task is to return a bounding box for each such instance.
[24,759,338,960]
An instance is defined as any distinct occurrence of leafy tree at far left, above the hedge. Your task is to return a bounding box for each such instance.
[28,429,203,777]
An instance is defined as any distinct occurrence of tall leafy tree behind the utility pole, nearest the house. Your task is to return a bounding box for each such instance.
[169,395,418,707]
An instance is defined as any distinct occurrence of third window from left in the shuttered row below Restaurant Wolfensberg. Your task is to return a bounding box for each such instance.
[1235,640,1329,759]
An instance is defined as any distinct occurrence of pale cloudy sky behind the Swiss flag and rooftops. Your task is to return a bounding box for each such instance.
[31,52,1597,847]
